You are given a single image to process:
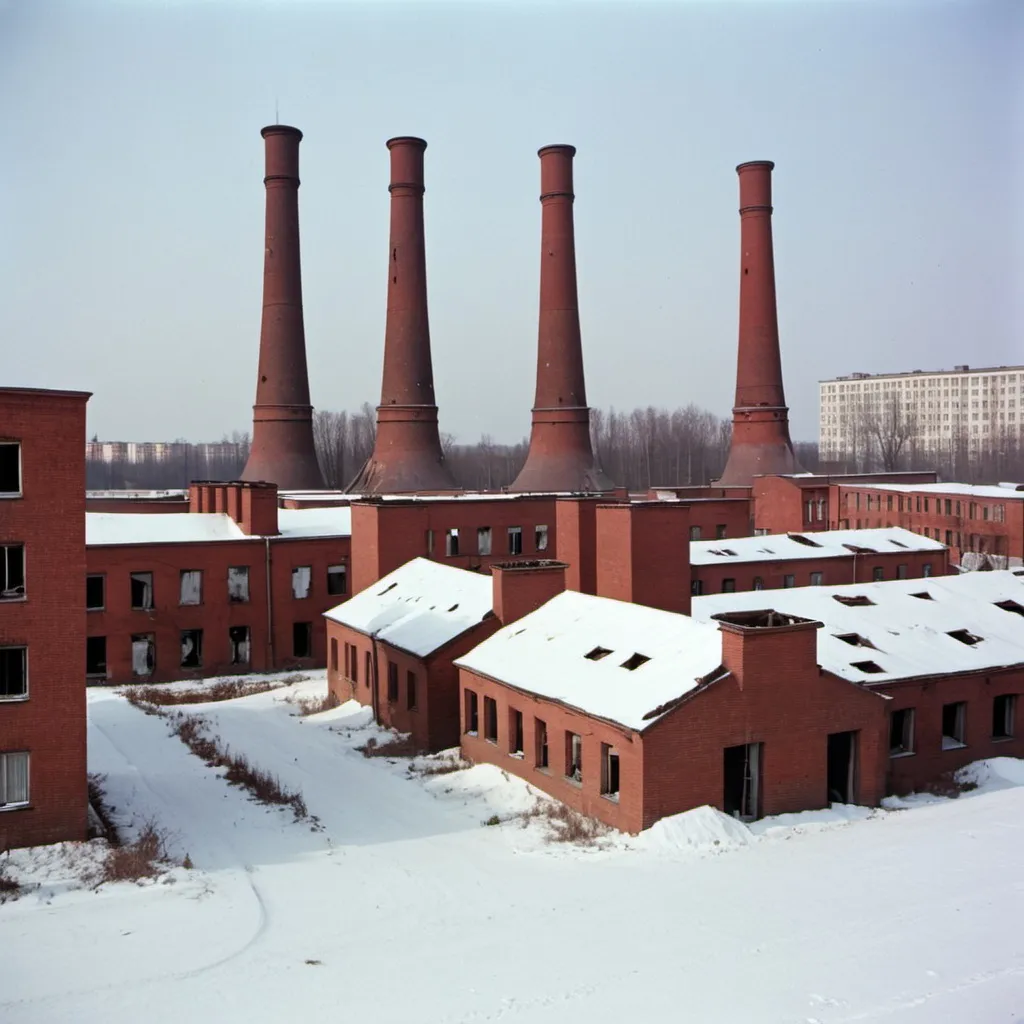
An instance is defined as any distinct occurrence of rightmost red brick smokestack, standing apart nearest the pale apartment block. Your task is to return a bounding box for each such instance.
[718,160,800,487]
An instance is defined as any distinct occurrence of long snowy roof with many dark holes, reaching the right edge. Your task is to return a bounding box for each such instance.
[692,569,1024,686]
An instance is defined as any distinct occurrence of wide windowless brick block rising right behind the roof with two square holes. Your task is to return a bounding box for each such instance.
[597,501,690,615]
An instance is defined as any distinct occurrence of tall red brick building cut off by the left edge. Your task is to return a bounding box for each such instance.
[0,388,89,850]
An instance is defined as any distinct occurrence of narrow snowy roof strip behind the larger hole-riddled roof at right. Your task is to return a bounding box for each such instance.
[690,526,945,565]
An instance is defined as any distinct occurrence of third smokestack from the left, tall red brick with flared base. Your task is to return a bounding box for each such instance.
[509,145,612,493]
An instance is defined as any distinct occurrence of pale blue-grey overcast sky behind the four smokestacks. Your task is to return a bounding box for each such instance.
[0,0,1024,441]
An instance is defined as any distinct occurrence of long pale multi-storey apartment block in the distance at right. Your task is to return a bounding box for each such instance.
[818,366,1024,468]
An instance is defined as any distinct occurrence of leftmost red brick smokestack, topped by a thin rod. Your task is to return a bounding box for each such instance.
[242,125,324,490]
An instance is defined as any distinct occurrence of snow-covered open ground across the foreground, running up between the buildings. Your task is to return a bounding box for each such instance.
[0,674,1024,1024]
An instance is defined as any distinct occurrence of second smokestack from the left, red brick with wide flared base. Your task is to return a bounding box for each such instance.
[348,137,456,495]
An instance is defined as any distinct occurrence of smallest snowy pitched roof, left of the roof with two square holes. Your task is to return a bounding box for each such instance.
[324,558,492,657]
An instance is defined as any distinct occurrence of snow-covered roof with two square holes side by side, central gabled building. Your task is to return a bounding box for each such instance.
[456,591,722,730]
